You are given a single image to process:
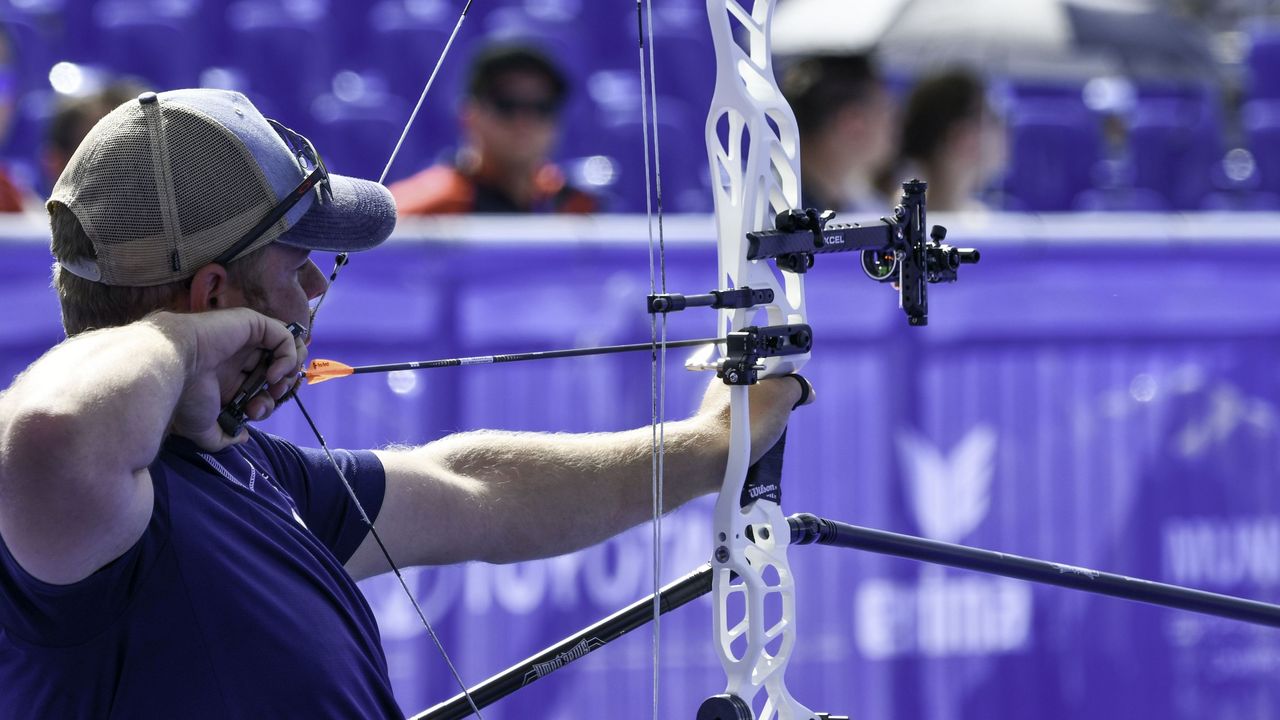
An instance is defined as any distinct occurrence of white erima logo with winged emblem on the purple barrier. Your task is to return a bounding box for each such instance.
[854,425,1032,660]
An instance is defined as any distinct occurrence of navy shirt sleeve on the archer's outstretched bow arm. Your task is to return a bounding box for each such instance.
[250,429,387,562]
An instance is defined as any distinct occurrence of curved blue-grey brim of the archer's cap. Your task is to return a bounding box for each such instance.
[276,174,396,252]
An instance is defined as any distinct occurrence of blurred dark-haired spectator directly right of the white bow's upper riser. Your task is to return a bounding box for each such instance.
[782,55,897,214]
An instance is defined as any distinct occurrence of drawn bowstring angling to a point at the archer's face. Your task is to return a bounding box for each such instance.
[293,0,484,720]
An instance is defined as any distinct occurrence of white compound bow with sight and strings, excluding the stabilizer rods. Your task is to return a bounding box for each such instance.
[280,0,978,720]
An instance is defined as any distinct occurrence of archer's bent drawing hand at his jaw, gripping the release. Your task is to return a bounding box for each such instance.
[148,307,306,451]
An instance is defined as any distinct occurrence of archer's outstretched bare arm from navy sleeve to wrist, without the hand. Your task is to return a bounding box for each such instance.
[371,416,727,566]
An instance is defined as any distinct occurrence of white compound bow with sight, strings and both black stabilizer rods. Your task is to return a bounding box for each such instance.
[290,0,1280,720]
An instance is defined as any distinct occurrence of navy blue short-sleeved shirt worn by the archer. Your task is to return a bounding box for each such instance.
[0,430,403,719]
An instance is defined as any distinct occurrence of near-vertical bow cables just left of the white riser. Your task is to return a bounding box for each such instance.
[636,0,667,720]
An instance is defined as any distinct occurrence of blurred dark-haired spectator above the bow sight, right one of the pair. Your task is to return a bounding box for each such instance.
[892,69,1009,211]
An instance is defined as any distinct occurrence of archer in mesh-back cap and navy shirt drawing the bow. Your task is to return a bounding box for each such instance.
[0,90,800,719]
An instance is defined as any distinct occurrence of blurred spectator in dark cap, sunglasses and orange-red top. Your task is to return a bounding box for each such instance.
[390,45,598,215]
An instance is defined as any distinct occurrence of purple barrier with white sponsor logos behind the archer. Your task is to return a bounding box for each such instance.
[0,218,1280,720]
